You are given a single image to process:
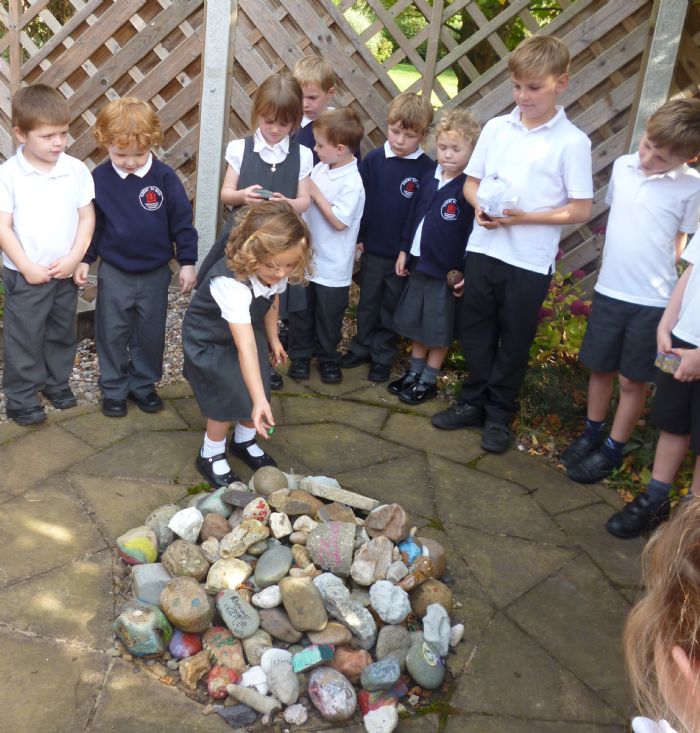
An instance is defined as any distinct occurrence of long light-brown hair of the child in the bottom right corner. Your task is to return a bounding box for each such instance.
[623,497,700,725]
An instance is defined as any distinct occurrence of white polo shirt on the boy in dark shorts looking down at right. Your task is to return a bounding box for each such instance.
[595,153,700,308]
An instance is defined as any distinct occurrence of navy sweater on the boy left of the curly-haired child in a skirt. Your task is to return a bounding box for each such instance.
[357,145,435,259]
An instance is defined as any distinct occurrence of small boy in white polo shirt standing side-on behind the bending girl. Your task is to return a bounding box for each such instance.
[288,107,365,384]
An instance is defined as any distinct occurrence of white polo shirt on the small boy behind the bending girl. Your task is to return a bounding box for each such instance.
[302,158,365,288]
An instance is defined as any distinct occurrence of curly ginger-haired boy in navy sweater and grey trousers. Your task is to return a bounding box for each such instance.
[79,97,197,417]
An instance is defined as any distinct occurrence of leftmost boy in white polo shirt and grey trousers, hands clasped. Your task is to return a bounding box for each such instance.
[0,84,95,425]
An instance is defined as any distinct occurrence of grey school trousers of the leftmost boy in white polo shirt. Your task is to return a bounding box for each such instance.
[2,267,78,410]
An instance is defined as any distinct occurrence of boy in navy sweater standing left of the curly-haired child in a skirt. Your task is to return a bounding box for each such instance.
[340,92,435,382]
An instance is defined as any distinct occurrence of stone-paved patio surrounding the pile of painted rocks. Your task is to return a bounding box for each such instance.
[0,368,642,733]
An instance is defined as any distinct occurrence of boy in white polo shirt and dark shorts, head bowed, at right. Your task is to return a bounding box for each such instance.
[561,99,700,483]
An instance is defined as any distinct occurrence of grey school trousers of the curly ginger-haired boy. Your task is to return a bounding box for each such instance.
[95,260,172,400]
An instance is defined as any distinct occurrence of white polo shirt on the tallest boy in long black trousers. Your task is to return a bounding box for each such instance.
[466,107,593,274]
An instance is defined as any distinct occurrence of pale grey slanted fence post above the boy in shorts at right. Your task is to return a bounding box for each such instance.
[628,0,688,152]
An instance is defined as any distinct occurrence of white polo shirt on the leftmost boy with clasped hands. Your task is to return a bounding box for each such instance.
[0,145,95,270]
